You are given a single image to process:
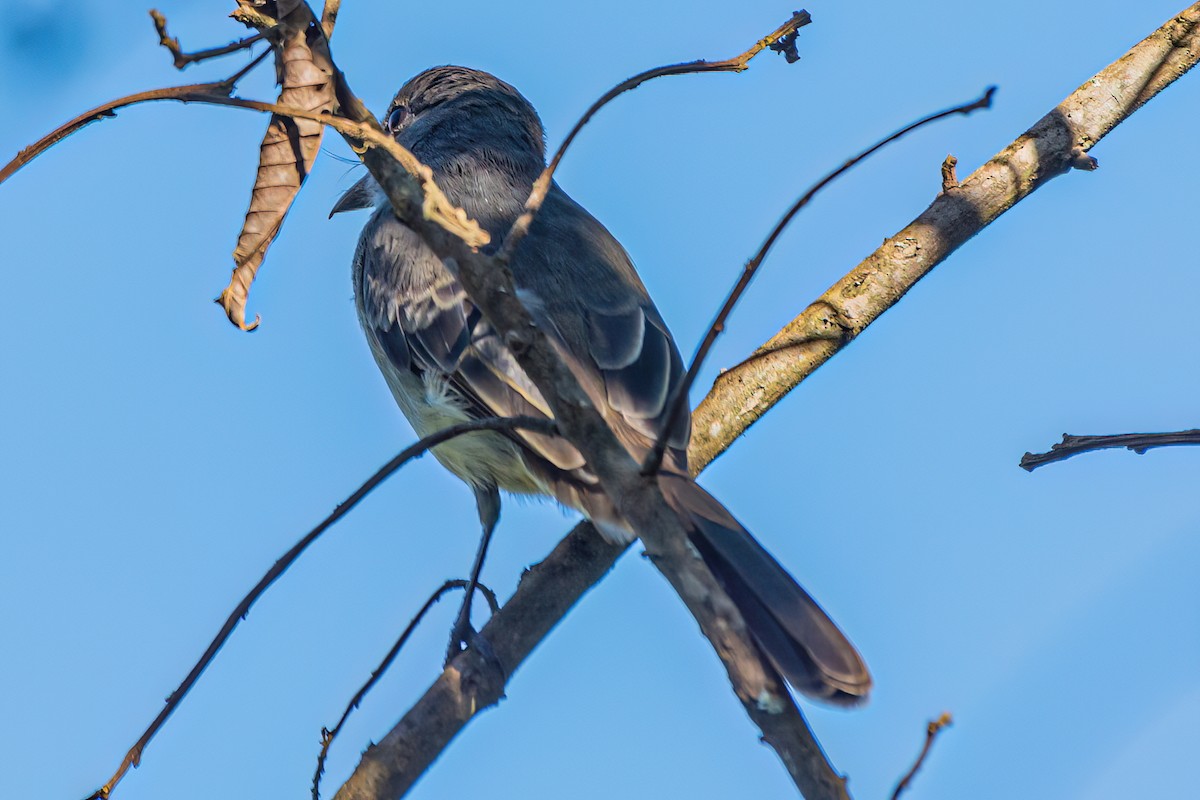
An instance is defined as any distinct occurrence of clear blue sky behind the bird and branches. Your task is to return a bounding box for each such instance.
[0,0,1200,800]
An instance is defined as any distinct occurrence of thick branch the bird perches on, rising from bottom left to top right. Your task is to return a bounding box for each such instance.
[338,4,1200,800]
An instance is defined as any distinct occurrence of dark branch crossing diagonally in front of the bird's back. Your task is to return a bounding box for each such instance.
[328,38,846,799]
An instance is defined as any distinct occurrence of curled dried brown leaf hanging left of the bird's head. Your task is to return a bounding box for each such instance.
[217,0,337,331]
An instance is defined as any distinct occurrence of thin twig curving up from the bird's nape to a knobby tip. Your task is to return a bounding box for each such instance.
[497,10,812,264]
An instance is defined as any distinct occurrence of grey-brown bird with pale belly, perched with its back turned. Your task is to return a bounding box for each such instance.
[330,66,871,705]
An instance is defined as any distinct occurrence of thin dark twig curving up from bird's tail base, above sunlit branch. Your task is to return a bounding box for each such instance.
[642,86,996,475]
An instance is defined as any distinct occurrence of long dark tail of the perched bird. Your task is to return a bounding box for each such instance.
[659,473,871,705]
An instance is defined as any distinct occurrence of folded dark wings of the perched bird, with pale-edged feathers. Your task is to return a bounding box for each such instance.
[359,186,690,481]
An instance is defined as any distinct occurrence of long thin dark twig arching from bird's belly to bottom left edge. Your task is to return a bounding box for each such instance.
[89,416,557,800]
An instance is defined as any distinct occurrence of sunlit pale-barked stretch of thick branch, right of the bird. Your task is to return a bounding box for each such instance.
[690,2,1200,463]
